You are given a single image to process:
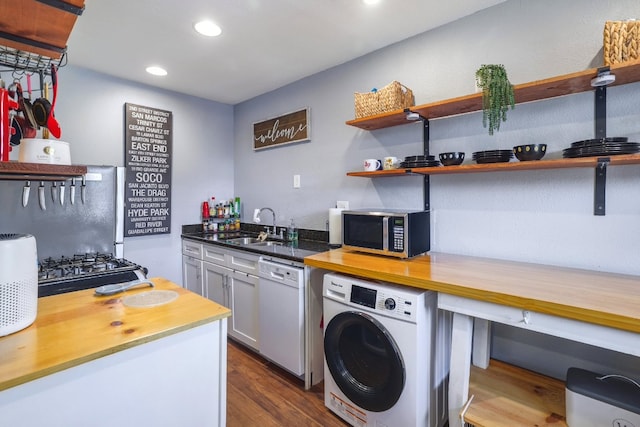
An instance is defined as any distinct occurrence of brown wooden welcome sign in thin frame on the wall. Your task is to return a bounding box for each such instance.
[253,108,311,150]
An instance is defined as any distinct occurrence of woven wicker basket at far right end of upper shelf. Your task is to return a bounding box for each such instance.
[603,21,640,65]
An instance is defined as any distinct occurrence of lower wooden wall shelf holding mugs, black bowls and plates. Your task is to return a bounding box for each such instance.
[347,154,640,178]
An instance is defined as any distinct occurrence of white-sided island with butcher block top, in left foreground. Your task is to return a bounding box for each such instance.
[0,278,231,426]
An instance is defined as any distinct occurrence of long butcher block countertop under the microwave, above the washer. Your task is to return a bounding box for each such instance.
[304,249,640,333]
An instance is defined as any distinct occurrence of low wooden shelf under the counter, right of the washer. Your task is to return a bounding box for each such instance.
[464,360,567,427]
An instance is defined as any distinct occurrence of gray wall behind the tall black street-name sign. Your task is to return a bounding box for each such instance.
[11,66,234,283]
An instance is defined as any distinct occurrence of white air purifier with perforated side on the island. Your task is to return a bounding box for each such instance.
[0,234,38,337]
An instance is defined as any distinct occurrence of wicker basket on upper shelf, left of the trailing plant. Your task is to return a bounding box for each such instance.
[354,80,415,119]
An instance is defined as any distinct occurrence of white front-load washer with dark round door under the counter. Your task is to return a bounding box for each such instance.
[323,273,451,427]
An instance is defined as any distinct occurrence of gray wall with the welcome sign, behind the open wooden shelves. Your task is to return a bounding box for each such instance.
[234,0,640,274]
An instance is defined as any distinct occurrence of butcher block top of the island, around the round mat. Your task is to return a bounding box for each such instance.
[0,278,231,390]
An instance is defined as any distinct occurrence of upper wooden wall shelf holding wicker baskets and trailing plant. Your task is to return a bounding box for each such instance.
[346,61,640,130]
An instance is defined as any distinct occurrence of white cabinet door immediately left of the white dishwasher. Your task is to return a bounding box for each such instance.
[229,271,260,350]
